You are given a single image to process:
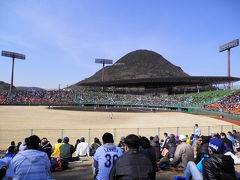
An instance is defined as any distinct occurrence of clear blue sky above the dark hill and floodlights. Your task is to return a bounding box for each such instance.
[0,0,240,89]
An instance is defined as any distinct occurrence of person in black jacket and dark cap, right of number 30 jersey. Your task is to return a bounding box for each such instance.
[110,134,155,180]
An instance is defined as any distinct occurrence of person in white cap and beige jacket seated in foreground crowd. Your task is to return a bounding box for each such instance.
[170,135,194,168]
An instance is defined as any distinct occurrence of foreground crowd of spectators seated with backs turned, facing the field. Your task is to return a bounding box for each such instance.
[0,124,240,180]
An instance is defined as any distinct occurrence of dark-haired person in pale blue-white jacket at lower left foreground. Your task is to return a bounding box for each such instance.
[9,135,50,180]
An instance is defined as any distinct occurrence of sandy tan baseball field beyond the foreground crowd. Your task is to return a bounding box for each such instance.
[0,106,239,149]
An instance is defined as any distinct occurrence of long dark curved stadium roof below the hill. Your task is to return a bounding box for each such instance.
[77,76,240,87]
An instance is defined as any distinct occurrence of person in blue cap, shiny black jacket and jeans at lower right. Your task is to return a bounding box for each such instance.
[184,138,237,180]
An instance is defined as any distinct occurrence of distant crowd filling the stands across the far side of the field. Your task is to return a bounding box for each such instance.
[0,89,240,114]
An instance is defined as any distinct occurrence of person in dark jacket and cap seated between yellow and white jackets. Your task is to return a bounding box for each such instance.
[60,137,75,162]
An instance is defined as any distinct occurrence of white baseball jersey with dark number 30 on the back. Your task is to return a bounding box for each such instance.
[93,143,123,180]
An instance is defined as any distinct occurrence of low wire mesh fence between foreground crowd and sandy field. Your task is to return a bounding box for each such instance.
[0,125,240,150]
